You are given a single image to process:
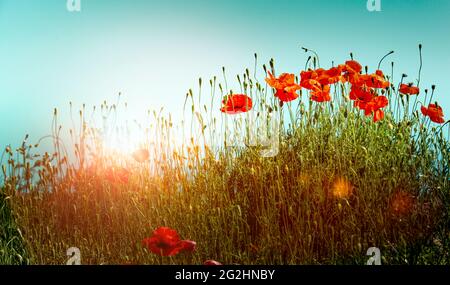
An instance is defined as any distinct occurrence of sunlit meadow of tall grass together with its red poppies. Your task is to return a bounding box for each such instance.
[0,47,450,265]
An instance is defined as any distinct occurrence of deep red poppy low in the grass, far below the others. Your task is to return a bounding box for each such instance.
[142,227,196,256]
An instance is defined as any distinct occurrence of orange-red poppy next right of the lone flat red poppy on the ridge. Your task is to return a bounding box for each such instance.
[266,72,301,102]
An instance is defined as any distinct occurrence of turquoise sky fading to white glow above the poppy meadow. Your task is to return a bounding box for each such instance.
[0,0,450,150]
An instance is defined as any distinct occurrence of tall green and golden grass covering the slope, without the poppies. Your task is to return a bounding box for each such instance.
[1,50,450,264]
